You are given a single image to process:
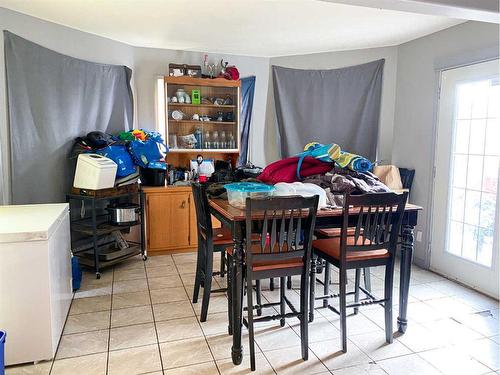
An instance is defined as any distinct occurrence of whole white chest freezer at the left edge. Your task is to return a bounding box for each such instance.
[0,203,72,365]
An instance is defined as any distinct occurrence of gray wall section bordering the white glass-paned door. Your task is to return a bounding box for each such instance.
[392,22,499,267]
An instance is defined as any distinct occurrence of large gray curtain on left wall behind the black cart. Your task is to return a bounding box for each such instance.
[4,31,133,204]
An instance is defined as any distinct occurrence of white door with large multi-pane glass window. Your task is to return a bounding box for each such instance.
[431,60,500,298]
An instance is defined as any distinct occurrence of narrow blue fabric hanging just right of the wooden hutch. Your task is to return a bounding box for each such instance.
[235,76,255,166]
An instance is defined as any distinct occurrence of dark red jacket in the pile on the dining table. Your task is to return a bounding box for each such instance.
[257,156,333,184]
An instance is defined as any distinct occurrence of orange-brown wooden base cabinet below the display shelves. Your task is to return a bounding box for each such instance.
[144,187,196,252]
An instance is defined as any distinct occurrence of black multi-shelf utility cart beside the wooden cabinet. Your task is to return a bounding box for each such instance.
[66,184,147,279]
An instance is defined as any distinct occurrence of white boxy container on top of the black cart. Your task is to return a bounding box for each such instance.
[73,154,118,190]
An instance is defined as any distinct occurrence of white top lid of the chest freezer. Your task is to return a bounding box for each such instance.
[0,203,69,243]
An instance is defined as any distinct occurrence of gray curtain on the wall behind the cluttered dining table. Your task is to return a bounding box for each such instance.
[273,59,385,160]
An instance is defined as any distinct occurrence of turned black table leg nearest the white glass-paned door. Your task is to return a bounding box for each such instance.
[398,224,414,333]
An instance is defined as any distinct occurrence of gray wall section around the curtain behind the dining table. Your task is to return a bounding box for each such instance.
[266,47,397,162]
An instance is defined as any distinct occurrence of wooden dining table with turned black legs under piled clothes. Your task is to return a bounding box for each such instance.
[209,198,422,365]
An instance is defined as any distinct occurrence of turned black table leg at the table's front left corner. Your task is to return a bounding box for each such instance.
[231,232,243,365]
